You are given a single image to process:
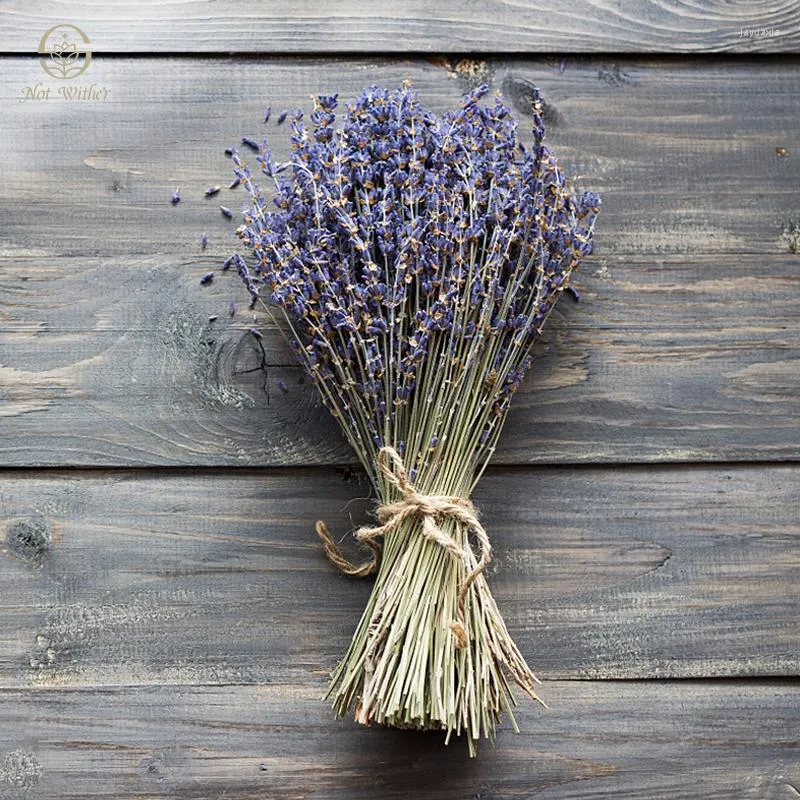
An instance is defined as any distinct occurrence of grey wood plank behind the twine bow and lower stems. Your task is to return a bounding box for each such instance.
[0,465,800,687]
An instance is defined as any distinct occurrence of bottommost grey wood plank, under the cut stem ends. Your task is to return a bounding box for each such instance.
[0,676,800,800]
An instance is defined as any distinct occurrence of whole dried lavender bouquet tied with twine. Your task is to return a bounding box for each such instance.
[228,84,600,754]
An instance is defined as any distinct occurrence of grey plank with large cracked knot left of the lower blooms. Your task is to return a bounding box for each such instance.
[0,256,800,466]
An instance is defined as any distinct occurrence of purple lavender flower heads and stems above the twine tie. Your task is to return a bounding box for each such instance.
[228,84,600,478]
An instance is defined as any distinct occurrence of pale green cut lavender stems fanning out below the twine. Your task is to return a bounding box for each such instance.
[328,482,539,755]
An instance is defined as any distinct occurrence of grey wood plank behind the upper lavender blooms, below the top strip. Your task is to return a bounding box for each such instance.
[0,58,800,260]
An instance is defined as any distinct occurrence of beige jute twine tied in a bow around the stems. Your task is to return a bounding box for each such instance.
[316,447,492,647]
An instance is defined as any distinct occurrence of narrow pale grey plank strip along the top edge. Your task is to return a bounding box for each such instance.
[0,0,800,54]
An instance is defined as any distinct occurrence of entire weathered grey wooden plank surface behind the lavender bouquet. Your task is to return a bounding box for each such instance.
[0,0,800,800]
